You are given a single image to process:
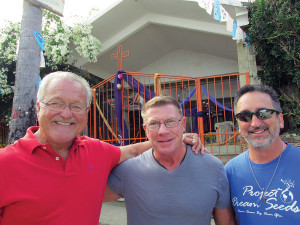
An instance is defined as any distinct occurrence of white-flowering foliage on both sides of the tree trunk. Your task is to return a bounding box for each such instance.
[0,10,101,123]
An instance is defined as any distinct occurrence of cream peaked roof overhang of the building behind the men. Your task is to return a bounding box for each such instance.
[76,0,246,76]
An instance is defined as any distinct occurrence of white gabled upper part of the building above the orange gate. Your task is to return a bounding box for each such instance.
[76,0,256,79]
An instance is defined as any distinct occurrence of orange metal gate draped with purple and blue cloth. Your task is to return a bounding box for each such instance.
[85,72,250,163]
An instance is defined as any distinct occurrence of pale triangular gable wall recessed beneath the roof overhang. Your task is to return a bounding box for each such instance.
[139,49,239,77]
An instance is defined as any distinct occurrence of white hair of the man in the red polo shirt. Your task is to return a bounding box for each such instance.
[37,71,92,108]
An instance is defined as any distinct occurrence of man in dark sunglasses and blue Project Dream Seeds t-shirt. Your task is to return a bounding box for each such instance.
[225,85,300,225]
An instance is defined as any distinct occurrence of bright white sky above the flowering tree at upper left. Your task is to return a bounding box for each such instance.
[0,0,117,28]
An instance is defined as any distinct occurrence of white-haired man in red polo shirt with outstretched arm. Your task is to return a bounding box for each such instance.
[0,72,201,225]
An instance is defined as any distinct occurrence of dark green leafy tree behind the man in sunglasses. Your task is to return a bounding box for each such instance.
[247,0,300,132]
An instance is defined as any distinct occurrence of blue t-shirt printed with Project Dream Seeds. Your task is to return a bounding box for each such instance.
[225,144,300,225]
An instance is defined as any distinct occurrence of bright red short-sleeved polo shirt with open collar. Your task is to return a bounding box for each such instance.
[0,127,121,225]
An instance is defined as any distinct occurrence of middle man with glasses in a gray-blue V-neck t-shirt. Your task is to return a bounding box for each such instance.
[104,96,235,225]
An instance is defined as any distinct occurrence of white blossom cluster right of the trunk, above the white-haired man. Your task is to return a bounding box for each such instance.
[43,10,101,70]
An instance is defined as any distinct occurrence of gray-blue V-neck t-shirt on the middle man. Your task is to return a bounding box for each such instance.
[108,146,230,225]
